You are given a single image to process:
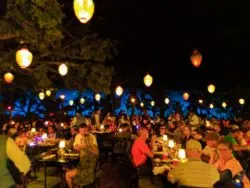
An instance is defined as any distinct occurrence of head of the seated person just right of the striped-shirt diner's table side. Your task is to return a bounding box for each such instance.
[217,139,233,160]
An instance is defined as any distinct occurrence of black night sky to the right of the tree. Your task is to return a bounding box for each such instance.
[0,0,250,91]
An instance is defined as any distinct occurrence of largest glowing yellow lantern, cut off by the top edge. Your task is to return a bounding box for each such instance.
[74,0,95,23]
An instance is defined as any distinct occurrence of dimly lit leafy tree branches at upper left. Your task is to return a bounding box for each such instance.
[0,0,117,93]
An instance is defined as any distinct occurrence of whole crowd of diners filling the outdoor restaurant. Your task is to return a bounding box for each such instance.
[0,110,250,188]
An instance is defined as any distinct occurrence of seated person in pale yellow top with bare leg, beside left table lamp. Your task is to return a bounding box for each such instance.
[65,123,99,188]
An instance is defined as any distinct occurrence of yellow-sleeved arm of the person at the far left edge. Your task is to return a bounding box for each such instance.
[6,138,31,174]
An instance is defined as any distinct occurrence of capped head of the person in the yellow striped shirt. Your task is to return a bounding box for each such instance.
[186,139,202,159]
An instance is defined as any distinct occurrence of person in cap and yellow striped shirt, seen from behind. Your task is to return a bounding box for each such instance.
[168,139,220,188]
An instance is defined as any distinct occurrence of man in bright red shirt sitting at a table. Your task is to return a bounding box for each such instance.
[131,127,154,167]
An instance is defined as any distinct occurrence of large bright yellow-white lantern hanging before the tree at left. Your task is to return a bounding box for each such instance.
[16,48,33,68]
